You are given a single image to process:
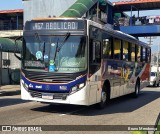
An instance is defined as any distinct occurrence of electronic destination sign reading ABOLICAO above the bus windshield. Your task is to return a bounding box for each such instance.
[25,21,84,31]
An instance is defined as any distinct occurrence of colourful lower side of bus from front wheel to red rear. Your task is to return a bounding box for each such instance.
[102,60,150,98]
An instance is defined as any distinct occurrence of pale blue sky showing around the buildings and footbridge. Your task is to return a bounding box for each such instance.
[0,0,160,52]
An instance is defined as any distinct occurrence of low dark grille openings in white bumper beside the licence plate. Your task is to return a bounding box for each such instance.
[29,90,69,100]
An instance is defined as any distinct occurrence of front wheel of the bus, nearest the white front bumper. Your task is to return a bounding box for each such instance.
[97,85,110,109]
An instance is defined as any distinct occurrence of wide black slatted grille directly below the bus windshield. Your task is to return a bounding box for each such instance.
[23,71,77,83]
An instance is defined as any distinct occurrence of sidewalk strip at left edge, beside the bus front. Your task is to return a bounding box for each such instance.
[0,85,20,96]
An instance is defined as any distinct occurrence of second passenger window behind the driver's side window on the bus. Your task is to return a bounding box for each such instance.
[113,39,121,60]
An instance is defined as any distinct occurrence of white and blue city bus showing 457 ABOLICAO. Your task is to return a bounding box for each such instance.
[20,18,151,108]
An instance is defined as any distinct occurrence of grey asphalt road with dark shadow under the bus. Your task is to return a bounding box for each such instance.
[0,87,160,134]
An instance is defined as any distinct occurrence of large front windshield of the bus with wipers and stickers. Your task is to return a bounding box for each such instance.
[22,34,87,73]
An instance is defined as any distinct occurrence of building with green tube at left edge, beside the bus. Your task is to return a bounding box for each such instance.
[0,9,23,85]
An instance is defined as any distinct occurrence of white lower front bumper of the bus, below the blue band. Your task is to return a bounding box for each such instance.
[21,83,89,105]
